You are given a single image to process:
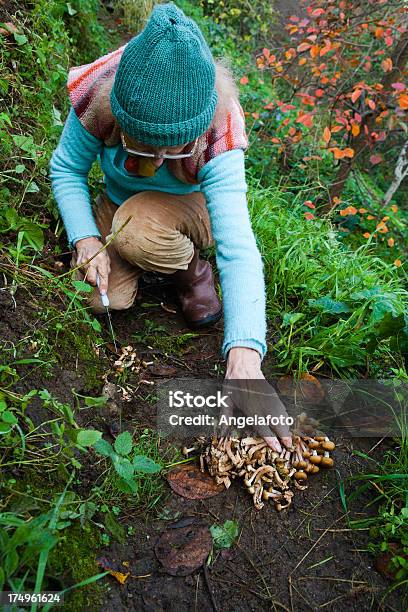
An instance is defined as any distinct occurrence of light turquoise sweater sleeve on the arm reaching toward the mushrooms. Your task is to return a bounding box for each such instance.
[198,149,266,358]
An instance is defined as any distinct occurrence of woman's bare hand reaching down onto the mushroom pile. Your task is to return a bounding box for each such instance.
[223,347,292,452]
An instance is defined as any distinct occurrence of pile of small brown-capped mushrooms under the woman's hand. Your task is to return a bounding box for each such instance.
[190,435,335,511]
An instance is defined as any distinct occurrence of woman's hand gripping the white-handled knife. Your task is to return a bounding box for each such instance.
[75,236,110,293]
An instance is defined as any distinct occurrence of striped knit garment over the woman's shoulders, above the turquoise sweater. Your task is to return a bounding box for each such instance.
[68,45,248,184]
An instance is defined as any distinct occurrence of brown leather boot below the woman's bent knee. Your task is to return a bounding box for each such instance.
[172,249,222,329]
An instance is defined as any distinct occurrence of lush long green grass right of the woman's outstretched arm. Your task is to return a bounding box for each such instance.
[249,179,408,377]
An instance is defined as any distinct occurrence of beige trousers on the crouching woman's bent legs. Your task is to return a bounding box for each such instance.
[71,191,213,313]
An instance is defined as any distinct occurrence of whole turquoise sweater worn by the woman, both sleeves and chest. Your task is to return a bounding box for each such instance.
[50,109,266,358]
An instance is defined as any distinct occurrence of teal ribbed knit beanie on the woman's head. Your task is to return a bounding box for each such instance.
[111,2,217,147]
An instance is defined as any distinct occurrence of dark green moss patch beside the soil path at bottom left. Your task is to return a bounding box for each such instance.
[47,525,106,612]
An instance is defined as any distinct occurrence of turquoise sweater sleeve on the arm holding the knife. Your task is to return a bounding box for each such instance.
[50,108,103,245]
